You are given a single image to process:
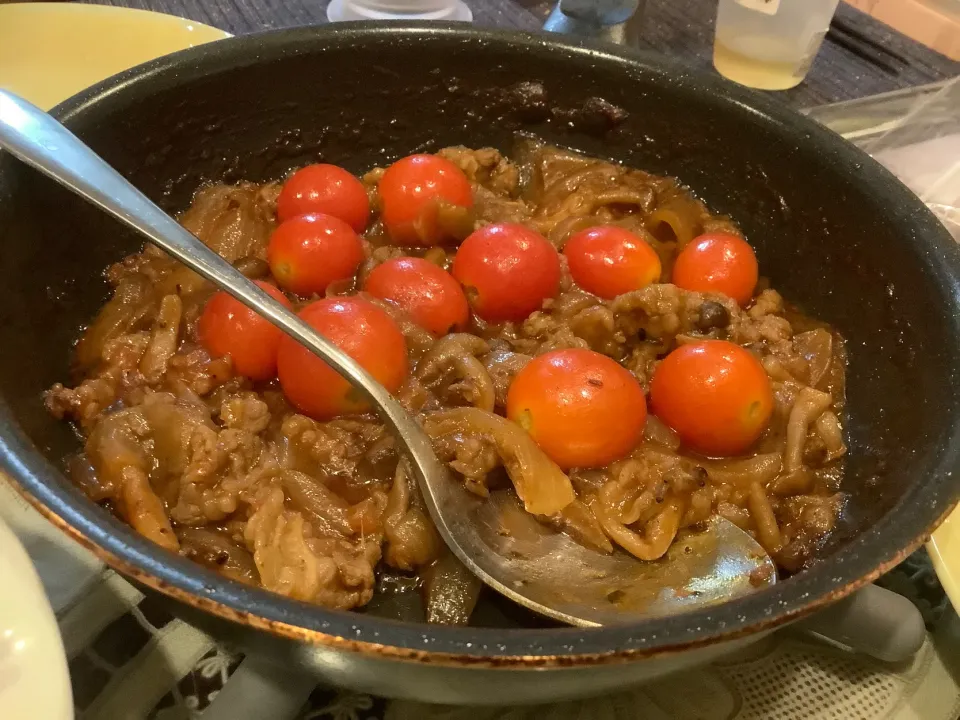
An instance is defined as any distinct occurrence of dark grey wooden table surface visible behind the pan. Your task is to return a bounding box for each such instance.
[83,0,960,107]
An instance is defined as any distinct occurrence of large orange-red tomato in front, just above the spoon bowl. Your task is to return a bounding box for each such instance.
[507,349,647,470]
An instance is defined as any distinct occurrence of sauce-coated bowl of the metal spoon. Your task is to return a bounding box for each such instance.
[434,483,777,627]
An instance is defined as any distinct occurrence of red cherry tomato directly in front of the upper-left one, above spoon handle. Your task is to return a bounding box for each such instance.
[267,214,363,295]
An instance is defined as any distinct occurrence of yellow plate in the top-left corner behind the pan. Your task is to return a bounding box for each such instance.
[0,3,230,110]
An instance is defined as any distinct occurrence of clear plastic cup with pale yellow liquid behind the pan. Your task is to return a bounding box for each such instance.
[713,0,839,90]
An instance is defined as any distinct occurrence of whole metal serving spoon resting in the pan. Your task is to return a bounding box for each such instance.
[0,91,776,626]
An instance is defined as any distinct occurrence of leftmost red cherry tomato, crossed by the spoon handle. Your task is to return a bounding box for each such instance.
[197,281,290,381]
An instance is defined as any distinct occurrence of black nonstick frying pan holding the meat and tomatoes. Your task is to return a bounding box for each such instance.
[0,25,960,702]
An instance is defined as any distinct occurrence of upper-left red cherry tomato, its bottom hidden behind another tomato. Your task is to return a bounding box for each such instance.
[277,163,370,233]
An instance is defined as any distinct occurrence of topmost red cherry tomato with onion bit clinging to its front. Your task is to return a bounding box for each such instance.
[378,155,473,247]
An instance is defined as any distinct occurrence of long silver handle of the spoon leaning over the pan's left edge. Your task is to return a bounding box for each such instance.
[0,90,445,510]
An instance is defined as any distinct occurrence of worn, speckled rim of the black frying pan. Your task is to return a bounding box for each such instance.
[0,23,960,668]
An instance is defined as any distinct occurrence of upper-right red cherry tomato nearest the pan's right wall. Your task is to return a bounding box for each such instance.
[673,233,758,305]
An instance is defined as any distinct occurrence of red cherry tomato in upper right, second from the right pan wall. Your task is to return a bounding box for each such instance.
[563,225,660,298]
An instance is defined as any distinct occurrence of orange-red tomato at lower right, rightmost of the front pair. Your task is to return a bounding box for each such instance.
[650,340,774,457]
